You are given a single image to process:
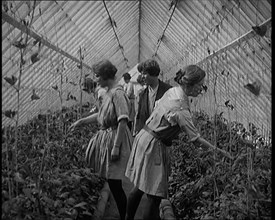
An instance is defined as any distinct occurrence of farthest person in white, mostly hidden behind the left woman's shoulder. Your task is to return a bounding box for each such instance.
[123,73,135,131]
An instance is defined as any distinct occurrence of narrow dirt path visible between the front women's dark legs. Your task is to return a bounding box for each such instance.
[103,177,146,220]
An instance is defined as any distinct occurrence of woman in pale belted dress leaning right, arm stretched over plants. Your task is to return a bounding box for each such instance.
[125,65,234,220]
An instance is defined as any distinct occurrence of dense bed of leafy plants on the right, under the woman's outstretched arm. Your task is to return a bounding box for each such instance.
[169,112,272,220]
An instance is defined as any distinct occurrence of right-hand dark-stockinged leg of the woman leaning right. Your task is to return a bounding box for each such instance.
[143,194,162,220]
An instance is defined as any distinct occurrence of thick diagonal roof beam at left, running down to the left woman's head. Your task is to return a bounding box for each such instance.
[2,10,92,70]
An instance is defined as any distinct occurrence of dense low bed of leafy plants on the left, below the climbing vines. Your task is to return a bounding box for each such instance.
[2,106,105,220]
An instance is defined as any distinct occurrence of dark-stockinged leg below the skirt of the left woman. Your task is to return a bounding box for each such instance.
[108,179,127,220]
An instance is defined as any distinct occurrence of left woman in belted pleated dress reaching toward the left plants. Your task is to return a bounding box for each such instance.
[70,60,133,220]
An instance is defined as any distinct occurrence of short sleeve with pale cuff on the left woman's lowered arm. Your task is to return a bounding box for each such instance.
[113,89,129,122]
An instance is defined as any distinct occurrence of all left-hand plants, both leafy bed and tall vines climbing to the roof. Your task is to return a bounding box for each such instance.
[1,4,104,219]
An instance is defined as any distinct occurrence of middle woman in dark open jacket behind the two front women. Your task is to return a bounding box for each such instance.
[133,59,171,136]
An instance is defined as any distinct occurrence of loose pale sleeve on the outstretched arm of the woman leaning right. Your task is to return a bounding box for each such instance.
[172,110,200,142]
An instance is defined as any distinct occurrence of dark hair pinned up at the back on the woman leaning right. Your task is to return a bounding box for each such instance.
[174,65,206,86]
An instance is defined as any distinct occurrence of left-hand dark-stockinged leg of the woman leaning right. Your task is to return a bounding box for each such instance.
[126,187,144,220]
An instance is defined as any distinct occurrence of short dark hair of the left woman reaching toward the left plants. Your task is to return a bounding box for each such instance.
[92,60,117,80]
